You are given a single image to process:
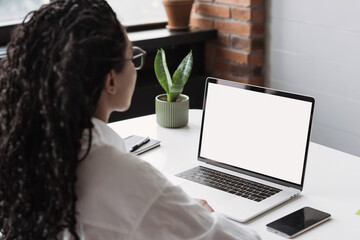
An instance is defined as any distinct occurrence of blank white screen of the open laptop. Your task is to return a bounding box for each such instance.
[199,83,312,184]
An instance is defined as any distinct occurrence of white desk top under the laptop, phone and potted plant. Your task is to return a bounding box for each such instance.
[109,110,360,240]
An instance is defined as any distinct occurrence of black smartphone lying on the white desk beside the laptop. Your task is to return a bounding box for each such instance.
[266,207,331,238]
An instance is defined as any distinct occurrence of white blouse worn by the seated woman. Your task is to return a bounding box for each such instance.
[76,118,260,240]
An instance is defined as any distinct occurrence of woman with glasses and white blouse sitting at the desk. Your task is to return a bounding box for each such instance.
[0,0,257,239]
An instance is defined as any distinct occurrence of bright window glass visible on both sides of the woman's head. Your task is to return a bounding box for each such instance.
[0,0,166,26]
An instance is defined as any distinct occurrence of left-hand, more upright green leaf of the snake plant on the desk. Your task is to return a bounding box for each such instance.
[154,48,172,93]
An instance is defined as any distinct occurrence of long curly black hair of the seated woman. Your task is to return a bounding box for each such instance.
[0,0,128,239]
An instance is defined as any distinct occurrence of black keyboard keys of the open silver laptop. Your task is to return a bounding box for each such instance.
[176,166,281,202]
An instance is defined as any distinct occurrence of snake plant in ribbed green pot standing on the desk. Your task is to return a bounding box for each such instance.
[154,49,193,128]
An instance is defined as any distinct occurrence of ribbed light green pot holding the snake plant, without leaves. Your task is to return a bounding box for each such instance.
[155,94,189,128]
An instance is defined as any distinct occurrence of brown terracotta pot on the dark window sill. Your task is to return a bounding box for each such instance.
[162,0,194,31]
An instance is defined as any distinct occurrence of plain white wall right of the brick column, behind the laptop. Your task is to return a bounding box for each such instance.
[264,0,360,156]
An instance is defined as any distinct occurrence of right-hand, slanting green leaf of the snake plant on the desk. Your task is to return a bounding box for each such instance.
[168,51,193,102]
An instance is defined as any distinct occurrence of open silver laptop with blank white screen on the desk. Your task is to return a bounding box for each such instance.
[176,77,315,222]
